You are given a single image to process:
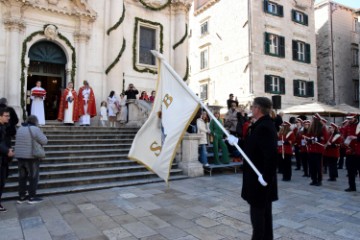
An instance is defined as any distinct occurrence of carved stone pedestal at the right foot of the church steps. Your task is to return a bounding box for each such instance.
[179,133,204,177]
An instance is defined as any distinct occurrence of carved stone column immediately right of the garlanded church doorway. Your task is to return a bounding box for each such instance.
[74,31,90,89]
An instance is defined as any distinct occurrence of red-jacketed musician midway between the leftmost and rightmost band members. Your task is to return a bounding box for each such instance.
[307,113,328,186]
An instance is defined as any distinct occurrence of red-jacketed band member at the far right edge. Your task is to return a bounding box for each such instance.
[344,114,360,192]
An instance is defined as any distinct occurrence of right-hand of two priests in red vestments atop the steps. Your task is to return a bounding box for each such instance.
[78,80,96,126]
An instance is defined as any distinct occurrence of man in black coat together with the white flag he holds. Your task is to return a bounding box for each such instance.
[128,51,277,239]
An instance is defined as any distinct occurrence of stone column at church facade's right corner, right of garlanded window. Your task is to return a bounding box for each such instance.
[172,0,191,77]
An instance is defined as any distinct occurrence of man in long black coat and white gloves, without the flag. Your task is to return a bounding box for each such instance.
[241,97,278,240]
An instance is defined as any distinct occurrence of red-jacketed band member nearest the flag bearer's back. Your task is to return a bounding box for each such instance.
[278,121,295,181]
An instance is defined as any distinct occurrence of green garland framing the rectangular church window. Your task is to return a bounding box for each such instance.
[133,17,164,74]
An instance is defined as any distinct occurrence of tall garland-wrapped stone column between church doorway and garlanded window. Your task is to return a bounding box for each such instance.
[106,0,124,95]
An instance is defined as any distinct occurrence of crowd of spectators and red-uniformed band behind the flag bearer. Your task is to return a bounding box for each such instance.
[195,94,360,192]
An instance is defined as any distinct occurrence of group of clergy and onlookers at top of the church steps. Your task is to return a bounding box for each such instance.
[30,80,155,127]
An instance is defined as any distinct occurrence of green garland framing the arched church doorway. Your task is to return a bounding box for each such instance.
[20,24,76,121]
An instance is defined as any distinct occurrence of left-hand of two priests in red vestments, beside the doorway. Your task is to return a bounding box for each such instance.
[58,82,79,125]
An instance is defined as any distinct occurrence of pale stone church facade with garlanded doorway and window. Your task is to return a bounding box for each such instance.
[0,0,192,120]
